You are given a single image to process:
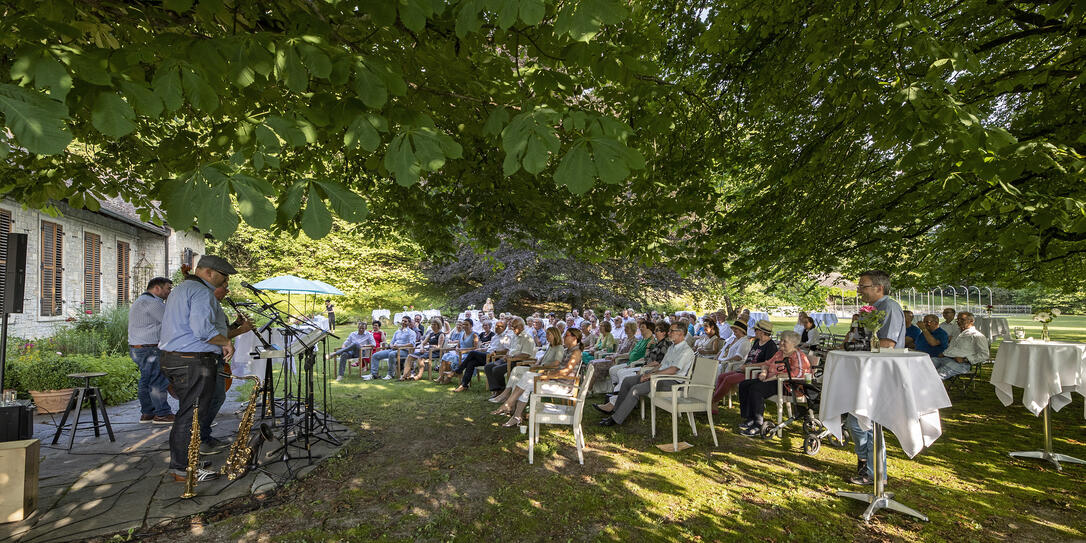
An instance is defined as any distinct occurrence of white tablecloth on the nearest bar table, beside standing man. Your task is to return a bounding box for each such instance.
[819,351,950,458]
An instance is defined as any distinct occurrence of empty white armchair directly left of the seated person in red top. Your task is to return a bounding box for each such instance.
[648,357,720,451]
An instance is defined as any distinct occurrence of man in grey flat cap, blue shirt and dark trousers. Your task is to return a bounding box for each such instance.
[159,254,238,482]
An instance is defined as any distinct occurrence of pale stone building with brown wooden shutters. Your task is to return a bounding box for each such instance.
[0,198,204,338]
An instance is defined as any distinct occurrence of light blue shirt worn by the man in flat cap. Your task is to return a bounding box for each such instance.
[159,278,226,353]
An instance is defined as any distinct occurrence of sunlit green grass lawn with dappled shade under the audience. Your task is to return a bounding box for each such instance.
[178,317,1086,542]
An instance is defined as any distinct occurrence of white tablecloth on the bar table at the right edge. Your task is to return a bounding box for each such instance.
[992,340,1086,417]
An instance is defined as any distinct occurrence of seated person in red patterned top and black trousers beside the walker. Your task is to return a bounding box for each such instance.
[738,330,811,435]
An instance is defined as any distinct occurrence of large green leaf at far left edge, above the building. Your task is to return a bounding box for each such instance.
[0,83,72,154]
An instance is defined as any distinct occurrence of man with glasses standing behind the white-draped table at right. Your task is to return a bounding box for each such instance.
[847,269,905,484]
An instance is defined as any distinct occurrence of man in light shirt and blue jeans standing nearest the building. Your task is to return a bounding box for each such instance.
[128,277,174,425]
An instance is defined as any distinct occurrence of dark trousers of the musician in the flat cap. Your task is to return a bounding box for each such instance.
[162,353,218,471]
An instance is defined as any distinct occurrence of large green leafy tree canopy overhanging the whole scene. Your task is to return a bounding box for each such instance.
[0,0,1086,293]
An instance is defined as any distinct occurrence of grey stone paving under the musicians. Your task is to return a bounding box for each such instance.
[0,391,354,543]
